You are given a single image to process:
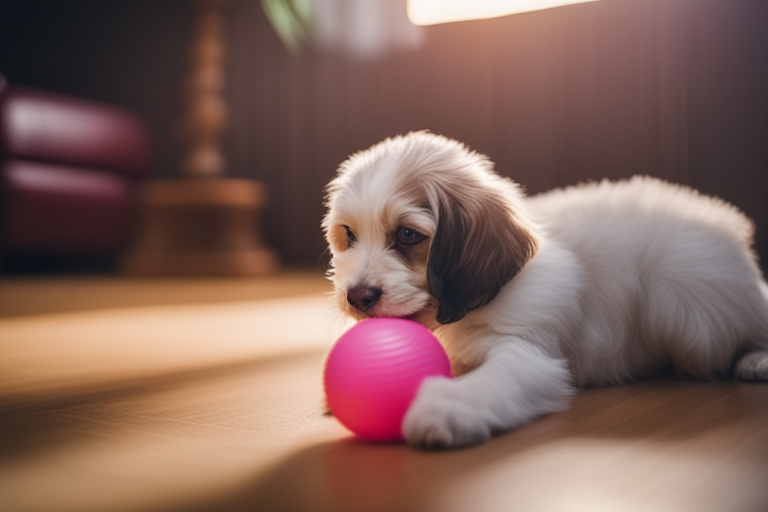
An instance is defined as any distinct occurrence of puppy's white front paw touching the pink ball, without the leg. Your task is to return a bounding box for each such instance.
[403,377,491,448]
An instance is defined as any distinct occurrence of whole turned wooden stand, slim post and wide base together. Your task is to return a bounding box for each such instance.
[122,0,279,275]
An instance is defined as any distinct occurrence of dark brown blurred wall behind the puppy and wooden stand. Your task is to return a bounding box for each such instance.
[0,0,768,272]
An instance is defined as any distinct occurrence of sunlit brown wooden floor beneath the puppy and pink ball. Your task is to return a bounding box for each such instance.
[0,272,768,512]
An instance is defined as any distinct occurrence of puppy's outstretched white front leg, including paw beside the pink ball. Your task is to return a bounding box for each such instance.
[402,340,573,448]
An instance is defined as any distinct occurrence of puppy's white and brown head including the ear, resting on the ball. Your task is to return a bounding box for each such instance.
[323,132,537,327]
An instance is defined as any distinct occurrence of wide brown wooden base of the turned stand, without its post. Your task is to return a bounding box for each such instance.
[122,178,280,276]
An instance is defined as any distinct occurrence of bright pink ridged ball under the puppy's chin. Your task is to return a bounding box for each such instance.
[324,318,451,441]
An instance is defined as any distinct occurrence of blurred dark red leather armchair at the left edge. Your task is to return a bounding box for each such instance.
[0,76,150,269]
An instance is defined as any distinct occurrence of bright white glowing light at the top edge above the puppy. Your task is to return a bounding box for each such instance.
[408,0,608,25]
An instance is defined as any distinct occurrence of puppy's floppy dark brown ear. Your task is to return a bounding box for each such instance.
[427,191,538,324]
